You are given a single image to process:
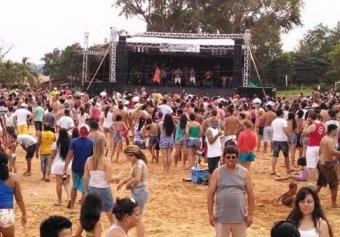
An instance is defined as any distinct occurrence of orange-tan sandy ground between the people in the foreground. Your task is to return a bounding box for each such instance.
[11,140,340,237]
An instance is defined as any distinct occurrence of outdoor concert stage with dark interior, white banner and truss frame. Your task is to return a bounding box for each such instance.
[82,29,251,95]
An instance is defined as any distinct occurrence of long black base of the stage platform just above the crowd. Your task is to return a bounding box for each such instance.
[85,82,237,96]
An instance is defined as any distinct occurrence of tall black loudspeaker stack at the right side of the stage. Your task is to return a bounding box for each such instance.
[232,39,243,88]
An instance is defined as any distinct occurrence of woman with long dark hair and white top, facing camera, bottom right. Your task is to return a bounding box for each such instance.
[287,187,333,237]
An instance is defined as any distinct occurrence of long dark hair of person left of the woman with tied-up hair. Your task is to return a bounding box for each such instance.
[80,193,102,231]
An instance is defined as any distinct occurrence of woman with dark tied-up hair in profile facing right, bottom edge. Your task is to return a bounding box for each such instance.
[106,198,141,237]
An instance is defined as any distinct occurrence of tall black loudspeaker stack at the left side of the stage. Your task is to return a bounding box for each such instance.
[116,36,128,84]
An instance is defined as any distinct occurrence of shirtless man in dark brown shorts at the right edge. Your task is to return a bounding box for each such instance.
[316,124,340,208]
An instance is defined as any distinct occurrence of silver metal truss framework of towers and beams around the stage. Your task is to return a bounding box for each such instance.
[82,27,251,86]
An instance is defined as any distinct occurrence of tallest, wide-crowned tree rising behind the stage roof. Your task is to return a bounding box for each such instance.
[115,0,302,65]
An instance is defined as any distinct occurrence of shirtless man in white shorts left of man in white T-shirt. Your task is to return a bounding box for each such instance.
[263,104,276,154]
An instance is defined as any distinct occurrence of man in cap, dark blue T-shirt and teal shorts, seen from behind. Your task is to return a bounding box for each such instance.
[64,124,94,210]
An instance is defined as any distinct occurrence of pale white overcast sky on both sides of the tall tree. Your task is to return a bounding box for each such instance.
[0,0,340,63]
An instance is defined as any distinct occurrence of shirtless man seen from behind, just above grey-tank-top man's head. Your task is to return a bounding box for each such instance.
[222,108,242,146]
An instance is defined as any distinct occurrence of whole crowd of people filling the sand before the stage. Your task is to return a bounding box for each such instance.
[0,84,340,237]
